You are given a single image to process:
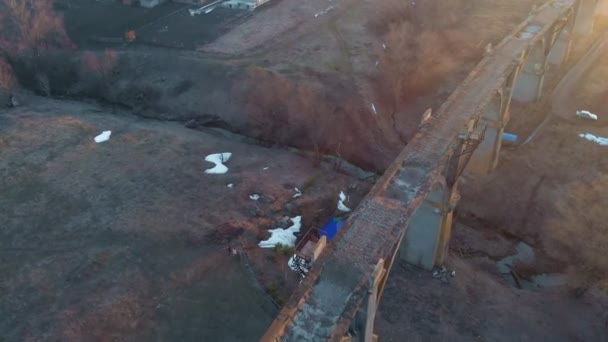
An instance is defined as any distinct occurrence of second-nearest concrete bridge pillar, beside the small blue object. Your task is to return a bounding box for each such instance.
[467,93,509,175]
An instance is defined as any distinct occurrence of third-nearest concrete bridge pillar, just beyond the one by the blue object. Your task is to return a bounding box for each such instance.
[512,41,547,102]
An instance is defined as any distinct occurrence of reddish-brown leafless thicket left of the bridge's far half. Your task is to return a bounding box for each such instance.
[368,0,470,126]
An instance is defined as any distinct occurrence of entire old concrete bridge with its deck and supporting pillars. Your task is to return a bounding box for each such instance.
[262,0,598,342]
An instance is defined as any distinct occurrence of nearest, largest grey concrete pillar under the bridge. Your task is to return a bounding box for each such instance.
[399,183,458,270]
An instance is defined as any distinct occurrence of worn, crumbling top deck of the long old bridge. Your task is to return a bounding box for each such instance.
[264,0,575,341]
